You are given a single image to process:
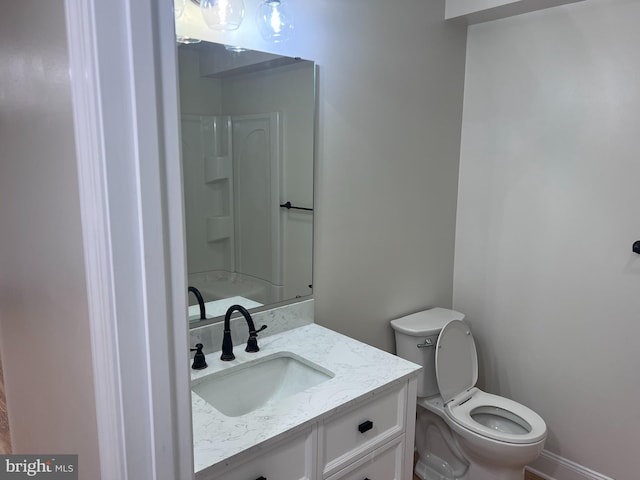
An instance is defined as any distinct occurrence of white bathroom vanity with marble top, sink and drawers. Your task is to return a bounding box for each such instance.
[192,324,420,480]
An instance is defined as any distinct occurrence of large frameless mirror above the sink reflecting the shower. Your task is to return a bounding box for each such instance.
[178,42,315,327]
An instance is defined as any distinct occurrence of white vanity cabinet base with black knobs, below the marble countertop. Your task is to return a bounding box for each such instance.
[196,378,416,480]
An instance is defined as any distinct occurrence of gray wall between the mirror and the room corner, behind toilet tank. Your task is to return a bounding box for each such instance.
[306,0,466,351]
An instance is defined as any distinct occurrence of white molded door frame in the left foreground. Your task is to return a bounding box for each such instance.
[64,0,193,480]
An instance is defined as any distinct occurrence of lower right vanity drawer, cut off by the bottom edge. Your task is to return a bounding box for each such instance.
[327,435,404,480]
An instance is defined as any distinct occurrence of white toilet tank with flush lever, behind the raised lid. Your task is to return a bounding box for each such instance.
[391,308,464,397]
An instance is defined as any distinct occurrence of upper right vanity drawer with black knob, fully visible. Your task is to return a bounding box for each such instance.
[319,384,407,478]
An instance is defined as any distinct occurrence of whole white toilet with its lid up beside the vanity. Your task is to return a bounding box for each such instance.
[391,308,547,480]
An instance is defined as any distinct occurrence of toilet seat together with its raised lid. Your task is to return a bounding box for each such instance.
[435,320,546,444]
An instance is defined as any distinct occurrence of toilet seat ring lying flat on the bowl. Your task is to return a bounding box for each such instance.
[444,387,547,444]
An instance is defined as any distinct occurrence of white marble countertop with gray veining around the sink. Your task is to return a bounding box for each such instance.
[191,324,421,473]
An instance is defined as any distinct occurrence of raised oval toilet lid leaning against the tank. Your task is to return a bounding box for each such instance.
[436,320,478,403]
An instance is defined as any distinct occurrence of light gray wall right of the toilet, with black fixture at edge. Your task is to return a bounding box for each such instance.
[454,0,640,480]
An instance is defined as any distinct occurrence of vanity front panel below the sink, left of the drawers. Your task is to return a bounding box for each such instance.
[218,430,316,480]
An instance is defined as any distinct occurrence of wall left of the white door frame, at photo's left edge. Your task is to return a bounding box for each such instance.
[0,0,100,479]
